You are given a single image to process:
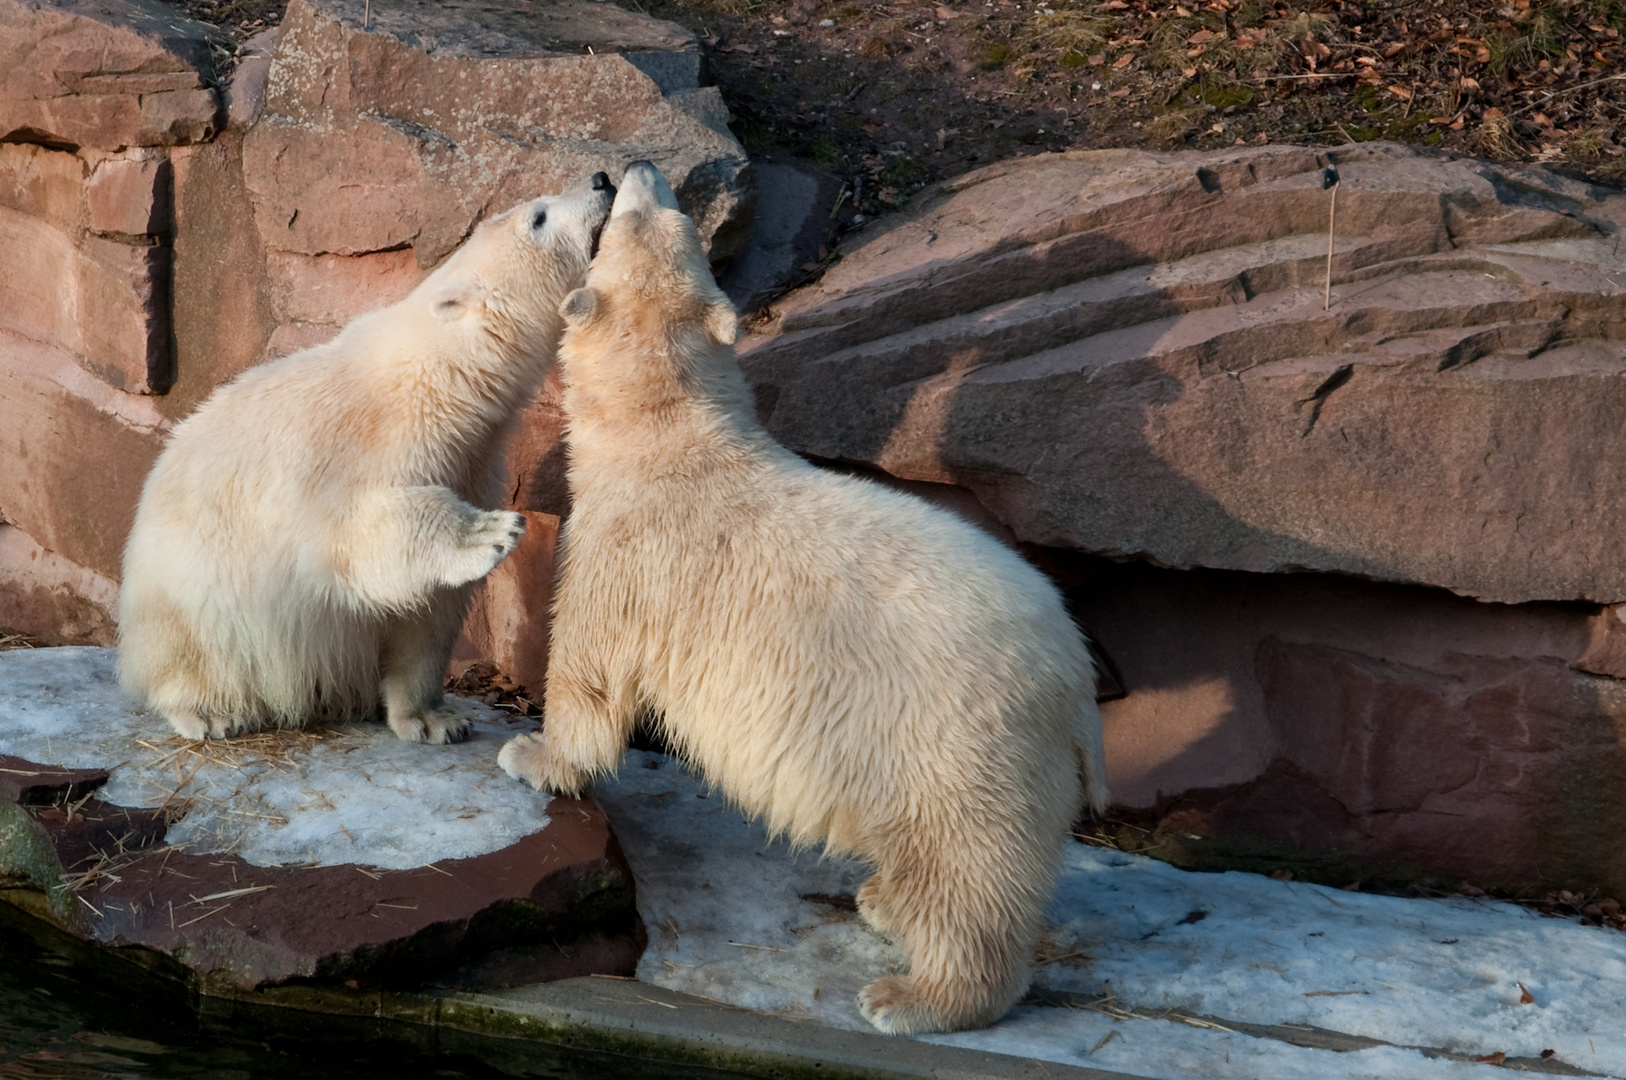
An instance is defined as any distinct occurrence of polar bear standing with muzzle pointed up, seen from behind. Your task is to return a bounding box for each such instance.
[499,163,1107,1033]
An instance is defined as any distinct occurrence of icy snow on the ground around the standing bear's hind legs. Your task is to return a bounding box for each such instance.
[593,751,1626,1080]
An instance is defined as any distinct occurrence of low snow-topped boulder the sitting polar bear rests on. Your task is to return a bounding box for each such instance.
[0,649,644,991]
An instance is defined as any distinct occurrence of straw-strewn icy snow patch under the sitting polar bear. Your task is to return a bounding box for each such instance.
[0,649,548,870]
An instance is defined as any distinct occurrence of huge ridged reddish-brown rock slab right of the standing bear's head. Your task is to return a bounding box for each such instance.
[743,145,1626,603]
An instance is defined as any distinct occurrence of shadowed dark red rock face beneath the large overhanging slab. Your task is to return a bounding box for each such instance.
[1068,560,1626,895]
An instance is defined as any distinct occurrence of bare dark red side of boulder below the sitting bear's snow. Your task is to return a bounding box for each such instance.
[0,780,642,991]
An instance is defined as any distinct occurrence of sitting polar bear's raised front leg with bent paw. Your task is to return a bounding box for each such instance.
[335,486,525,612]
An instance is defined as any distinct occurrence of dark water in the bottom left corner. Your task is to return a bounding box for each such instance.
[0,903,733,1080]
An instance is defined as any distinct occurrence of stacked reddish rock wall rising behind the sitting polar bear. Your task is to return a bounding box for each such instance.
[0,0,754,644]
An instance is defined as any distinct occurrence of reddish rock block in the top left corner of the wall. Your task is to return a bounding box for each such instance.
[0,0,221,150]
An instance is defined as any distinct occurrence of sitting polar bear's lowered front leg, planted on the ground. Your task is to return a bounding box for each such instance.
[380,586,472,743]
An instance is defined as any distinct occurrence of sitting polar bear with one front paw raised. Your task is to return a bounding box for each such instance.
[119,172,615,743]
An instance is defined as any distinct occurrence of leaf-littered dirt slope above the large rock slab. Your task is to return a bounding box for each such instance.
[621,0,1626,213]
